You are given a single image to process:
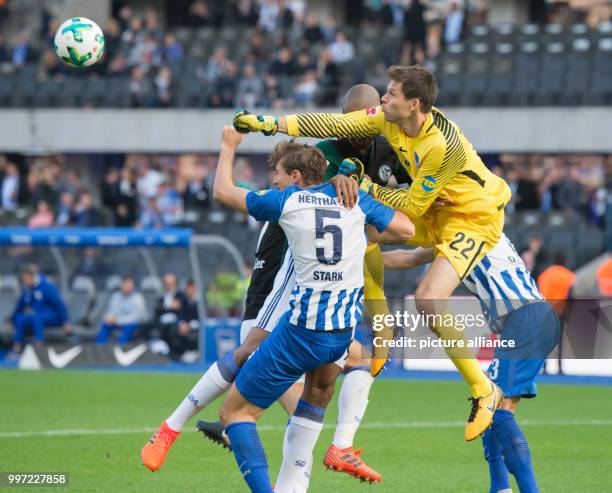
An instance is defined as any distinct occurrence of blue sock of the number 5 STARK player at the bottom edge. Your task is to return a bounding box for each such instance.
[225,422,273,493]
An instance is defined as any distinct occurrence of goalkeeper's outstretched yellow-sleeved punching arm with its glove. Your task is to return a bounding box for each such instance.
[233,108,385,139]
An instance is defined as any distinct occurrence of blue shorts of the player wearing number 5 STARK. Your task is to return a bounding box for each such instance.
[235,316,353,409]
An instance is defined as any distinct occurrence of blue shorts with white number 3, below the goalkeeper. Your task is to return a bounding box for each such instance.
[488,301,560,398]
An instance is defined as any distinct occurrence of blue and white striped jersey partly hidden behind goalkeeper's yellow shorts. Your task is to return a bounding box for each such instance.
[463,234,544,330]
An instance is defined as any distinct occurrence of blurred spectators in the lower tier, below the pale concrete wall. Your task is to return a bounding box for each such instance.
[0,154,612,229]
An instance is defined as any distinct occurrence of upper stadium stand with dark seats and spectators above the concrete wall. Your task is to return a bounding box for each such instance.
[0,2,612,108]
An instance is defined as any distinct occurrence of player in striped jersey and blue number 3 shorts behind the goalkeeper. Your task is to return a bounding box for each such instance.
[383,234,560,493]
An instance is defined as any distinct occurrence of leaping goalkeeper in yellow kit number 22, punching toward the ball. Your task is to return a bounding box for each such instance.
[234,66,511,440]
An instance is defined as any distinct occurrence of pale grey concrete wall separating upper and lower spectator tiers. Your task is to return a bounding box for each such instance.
[0,108,612,153]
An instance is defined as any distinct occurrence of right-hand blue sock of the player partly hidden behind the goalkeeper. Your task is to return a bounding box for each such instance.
[491,409,538,493]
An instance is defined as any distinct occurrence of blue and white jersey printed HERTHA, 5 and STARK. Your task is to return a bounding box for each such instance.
[246,184,394,330]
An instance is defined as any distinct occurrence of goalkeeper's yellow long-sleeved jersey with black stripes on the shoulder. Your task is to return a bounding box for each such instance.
[286,106,511,223]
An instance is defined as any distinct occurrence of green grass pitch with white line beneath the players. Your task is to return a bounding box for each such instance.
[0,371,612,493]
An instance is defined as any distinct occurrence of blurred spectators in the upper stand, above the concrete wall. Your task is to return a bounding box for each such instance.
[0,0,610,108]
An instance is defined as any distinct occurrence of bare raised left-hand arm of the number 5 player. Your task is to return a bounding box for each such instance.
[213,125,248,213]
